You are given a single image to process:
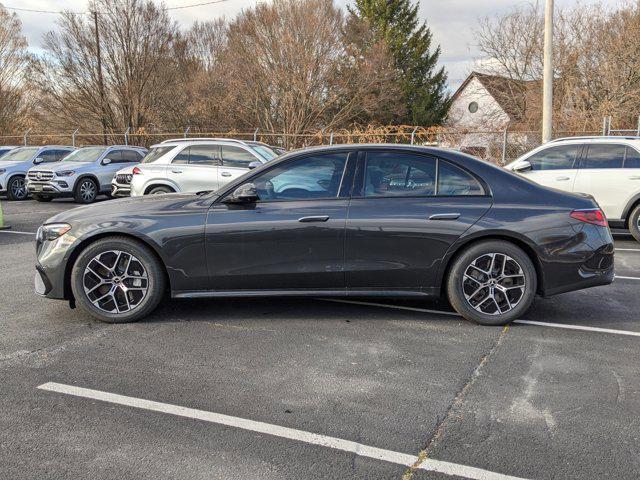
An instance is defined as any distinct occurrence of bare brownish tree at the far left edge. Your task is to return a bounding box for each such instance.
[0,5,32,133]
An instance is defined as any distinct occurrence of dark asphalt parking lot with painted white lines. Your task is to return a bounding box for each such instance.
[0,200,640,480]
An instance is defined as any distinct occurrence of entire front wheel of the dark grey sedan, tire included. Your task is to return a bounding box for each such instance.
[71,237,166,323]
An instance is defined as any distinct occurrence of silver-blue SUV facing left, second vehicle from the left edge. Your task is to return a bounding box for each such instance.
[27,145,147,203]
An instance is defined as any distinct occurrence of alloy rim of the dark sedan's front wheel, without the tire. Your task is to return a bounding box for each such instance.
[82,250,149,314]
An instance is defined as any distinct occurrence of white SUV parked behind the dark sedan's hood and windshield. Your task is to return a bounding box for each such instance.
[128,138,277,197]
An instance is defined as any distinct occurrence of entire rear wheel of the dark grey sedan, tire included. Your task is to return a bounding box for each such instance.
[446,240,538,325]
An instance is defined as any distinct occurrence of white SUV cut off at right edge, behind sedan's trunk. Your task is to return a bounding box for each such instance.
[506,137,640,242]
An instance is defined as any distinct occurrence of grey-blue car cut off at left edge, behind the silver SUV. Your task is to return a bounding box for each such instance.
[0,145,75,200]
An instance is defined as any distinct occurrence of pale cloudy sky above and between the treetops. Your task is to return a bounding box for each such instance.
[2,0,623,90]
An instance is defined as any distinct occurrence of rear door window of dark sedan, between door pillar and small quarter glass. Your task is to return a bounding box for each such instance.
[364,152,436,197]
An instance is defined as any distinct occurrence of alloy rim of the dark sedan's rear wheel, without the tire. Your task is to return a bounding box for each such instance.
[462,253,527,315]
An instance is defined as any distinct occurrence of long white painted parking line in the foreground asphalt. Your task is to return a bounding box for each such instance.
[38,382,523,480]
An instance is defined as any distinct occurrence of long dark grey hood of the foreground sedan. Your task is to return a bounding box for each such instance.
[44,193,216,225]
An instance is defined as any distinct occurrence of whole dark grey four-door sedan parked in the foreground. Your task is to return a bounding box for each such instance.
[35,145,614,325]
